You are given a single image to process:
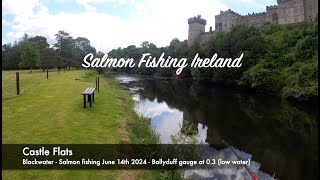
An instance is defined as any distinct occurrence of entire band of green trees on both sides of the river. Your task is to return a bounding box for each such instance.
[2,21,318,100]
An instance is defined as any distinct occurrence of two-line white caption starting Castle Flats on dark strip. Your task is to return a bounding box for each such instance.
[2,144,251,169]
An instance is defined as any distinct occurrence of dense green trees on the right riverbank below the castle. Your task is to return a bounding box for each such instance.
[104,22,318,100]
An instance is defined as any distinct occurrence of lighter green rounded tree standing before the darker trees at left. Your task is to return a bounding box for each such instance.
[18,41,40,73]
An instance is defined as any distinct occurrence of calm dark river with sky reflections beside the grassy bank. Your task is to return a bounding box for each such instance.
[114,74,318,180]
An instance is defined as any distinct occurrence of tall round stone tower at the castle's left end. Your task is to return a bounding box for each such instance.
[188,15,207,46]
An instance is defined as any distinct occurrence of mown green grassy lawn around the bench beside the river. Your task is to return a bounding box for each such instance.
[2,70,156,179]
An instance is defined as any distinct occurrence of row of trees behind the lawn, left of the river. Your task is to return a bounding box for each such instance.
[2,31,96,70]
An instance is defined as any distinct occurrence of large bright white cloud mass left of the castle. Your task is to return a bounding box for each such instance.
[3,0,227,52]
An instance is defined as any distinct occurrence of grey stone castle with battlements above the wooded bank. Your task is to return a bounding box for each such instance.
[188,0,318,46]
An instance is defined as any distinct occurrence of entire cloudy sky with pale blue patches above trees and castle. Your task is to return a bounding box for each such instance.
[2,0,276,53]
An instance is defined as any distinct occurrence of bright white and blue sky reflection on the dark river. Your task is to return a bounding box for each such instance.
[116,76,274,180]
